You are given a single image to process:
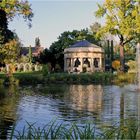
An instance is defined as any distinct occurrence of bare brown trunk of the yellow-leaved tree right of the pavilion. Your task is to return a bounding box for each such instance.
[120,43,125,72]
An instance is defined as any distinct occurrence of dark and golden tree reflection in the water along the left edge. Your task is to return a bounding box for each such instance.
[0,85,18,139]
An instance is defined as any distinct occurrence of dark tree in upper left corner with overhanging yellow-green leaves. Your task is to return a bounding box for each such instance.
[0,0,33,44]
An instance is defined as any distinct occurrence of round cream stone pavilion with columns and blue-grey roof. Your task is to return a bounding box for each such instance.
[64,40,104,72]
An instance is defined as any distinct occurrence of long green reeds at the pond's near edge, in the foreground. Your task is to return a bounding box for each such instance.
[5,120,139,140]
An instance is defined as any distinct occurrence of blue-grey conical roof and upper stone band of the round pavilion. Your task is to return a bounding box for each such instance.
[64,40,104,53]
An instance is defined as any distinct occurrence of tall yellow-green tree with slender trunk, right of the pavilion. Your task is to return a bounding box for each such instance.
[95,0,140,71]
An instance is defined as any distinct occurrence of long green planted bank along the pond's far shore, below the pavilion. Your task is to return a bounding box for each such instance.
[0,72,136,85]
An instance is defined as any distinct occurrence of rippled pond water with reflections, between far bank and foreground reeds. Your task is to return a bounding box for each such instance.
[0,85,140,139]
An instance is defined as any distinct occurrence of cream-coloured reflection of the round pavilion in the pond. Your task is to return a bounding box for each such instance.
[65,85,103,114]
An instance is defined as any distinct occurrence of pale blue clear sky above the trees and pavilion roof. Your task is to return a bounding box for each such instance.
[9,0,104,48]
